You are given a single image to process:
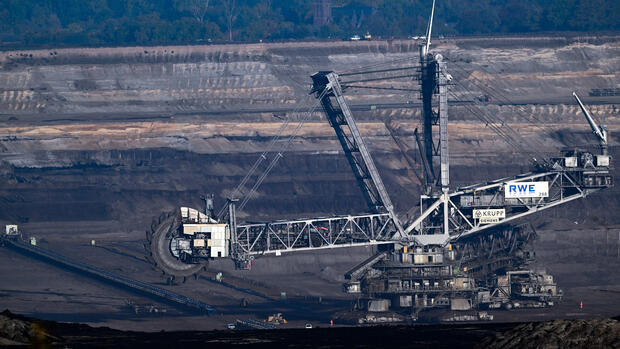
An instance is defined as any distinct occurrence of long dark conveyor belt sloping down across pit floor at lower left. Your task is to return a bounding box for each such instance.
[0,238,215,313]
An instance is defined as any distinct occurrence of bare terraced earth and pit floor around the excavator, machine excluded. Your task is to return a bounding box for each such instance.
[0,36,620,331]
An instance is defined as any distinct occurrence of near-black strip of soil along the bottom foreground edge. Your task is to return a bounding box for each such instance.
[0,311,620,348]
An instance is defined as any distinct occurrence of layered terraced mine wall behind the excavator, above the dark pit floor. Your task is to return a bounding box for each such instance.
[0,36,620,237]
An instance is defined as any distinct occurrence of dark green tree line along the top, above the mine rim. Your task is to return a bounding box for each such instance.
[0,0,620,46]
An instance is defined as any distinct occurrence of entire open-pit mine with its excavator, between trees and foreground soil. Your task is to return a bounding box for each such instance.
[0,29,620,331]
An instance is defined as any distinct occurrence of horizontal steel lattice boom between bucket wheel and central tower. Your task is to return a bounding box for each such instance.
[233,213,396,255]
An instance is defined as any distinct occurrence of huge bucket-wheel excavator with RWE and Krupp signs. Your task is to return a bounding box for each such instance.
[146,1,613,312]
